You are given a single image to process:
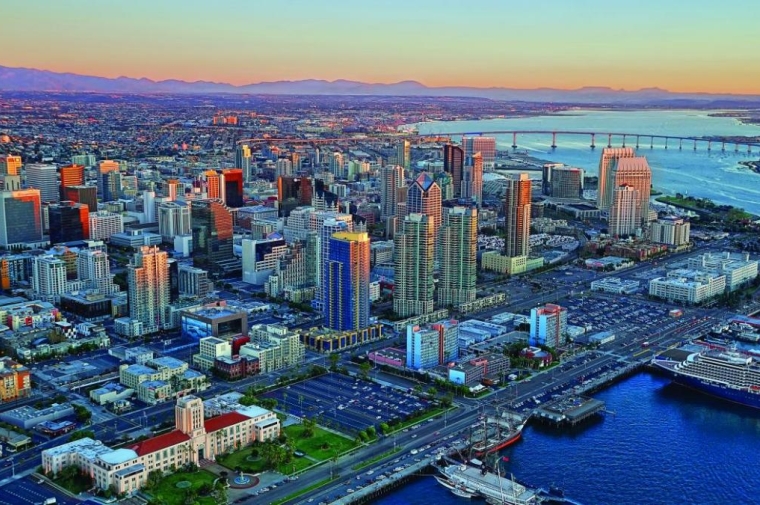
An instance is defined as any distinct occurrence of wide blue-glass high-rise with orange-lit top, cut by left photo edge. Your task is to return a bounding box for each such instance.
[0,189,42,248]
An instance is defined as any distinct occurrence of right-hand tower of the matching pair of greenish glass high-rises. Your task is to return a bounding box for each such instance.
[436,207,478,307]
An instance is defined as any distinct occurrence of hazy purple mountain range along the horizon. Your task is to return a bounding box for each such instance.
[0,65,760,106]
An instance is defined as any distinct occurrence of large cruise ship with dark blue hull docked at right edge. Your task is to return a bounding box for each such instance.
[652,349,760,409]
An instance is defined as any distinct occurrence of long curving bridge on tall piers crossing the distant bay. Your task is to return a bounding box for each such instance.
[237,130,760,153]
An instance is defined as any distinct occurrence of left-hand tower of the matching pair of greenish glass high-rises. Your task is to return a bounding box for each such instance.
[393,214,437,317]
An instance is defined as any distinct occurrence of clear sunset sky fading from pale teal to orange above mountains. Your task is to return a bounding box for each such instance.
[0,0,760,94]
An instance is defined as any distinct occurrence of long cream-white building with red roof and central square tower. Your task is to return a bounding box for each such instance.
[42,396,280,493]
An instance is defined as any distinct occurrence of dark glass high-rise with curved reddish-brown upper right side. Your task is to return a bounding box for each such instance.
[190,200,234,274]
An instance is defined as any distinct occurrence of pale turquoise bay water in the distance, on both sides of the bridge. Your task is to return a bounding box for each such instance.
[418,111,760,214]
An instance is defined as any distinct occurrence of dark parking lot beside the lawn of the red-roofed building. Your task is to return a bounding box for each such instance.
[264,373,427,433]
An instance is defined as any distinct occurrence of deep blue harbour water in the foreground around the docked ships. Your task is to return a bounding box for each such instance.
[377,373,760,505]
